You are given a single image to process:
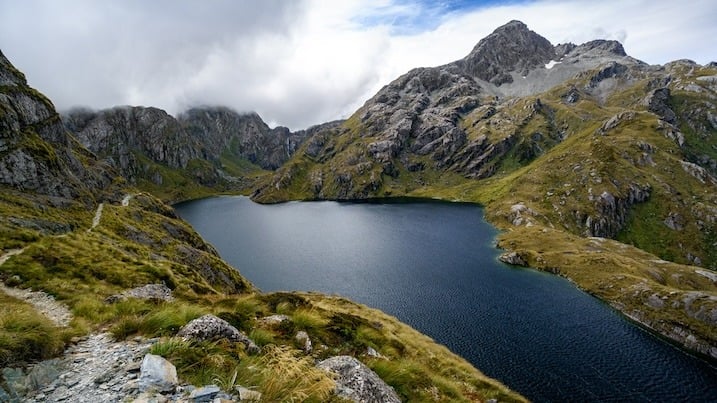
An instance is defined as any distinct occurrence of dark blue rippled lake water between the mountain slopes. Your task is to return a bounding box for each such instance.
[175,197,717,402]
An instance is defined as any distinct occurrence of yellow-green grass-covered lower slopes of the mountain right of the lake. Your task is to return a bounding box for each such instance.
[252,66,717,357]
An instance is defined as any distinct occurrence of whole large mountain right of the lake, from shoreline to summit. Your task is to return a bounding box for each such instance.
[252,21,717,358]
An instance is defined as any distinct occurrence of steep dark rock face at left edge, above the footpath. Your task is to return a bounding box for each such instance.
[0,52,112,198]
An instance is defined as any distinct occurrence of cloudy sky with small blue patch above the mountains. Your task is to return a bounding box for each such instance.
[0,0,717,130]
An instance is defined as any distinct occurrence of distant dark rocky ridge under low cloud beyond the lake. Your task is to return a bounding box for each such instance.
[62,106,318,201]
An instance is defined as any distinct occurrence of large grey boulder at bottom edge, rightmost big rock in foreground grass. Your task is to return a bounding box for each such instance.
[317,356,401,403]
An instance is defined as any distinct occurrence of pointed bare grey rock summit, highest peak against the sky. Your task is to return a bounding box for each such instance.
[452,20,555,86]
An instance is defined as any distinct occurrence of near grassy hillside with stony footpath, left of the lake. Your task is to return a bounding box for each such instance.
[0,53,525,402]
